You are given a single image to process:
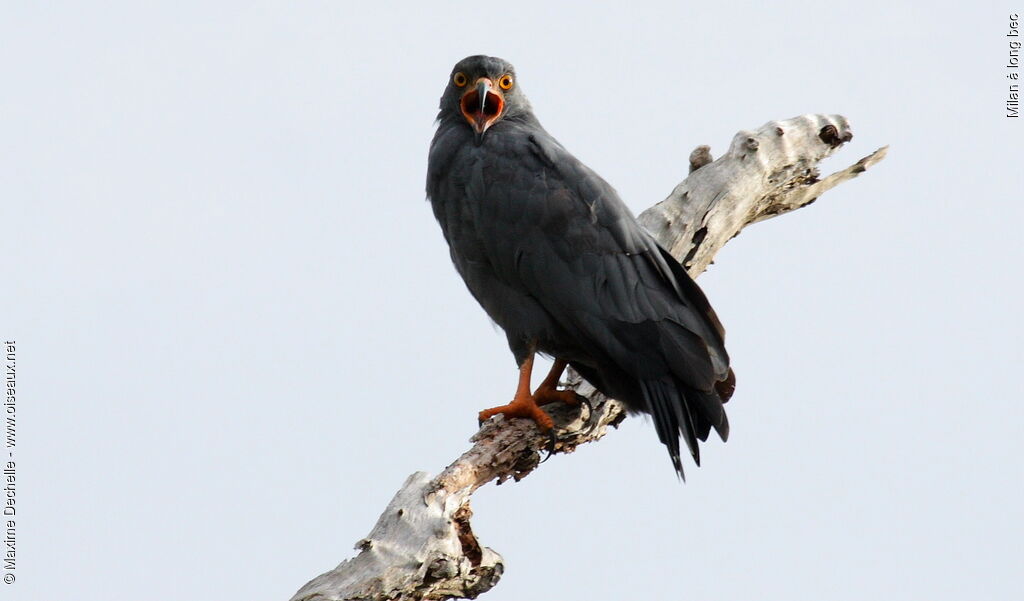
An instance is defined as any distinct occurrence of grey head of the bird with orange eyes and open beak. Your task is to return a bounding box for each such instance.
[438,54,529,142]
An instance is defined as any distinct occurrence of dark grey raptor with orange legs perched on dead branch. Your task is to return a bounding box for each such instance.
[426,55,735,479]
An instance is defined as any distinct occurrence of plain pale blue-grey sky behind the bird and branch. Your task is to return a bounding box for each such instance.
[0,1,1024,601]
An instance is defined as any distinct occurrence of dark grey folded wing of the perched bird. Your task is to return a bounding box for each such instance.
[469,130,728,390]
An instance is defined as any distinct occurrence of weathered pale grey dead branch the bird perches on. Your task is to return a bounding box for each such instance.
[292,115,887,601]
